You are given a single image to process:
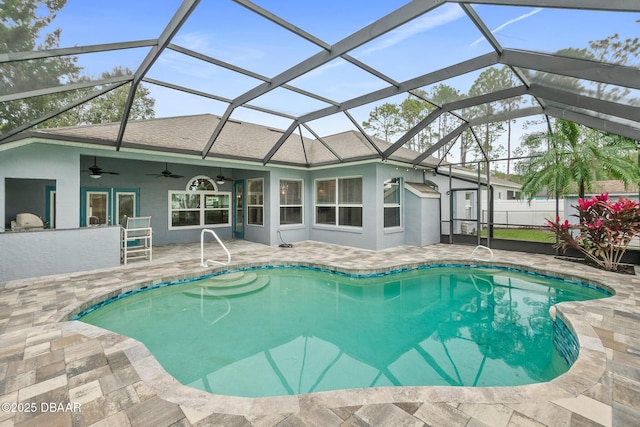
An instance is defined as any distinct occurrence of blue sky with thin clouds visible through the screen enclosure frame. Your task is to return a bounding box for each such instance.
[43,0,640,163]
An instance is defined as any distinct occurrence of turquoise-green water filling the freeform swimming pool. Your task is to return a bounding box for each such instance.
[81,267,606,397]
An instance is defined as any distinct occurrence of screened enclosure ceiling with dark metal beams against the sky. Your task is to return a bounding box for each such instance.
[0,0,640,166]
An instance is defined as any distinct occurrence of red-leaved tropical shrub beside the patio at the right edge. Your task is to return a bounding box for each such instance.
[547,194,640,271]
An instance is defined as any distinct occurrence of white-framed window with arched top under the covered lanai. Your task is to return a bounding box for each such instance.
[169,176,231,230]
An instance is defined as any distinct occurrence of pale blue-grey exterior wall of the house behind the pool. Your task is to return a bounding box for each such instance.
[0,139,504,278]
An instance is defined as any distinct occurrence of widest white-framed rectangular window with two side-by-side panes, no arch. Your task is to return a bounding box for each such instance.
[316,177,362,227]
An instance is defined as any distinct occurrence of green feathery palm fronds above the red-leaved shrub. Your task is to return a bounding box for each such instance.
[522,120,640,199]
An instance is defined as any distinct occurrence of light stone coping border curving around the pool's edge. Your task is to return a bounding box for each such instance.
[58,259,617,425]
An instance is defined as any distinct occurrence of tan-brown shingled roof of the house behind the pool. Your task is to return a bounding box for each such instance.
[27,114,436,167]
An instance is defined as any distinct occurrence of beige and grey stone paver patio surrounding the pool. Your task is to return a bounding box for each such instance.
[0,241,640,427]
